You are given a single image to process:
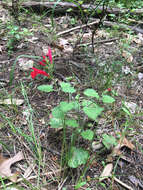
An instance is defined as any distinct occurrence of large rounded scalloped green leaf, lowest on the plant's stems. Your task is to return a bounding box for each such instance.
[68,147,89,168]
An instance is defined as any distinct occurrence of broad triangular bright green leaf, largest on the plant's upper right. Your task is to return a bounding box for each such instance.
[83,106,104,120]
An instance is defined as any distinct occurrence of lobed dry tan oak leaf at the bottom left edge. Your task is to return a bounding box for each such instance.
[0,152,24,182]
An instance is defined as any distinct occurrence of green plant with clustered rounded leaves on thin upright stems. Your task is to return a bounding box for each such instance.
[38,82,115,172]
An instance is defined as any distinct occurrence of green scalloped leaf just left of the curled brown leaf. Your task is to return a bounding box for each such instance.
[102,134,117,149]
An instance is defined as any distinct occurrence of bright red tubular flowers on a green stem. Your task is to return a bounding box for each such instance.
[31,48,53,79]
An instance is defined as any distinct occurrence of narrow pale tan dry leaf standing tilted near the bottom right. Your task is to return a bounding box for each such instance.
[99,163,113,181]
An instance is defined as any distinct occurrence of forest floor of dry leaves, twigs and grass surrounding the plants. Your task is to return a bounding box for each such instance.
[0,1,143,190]
